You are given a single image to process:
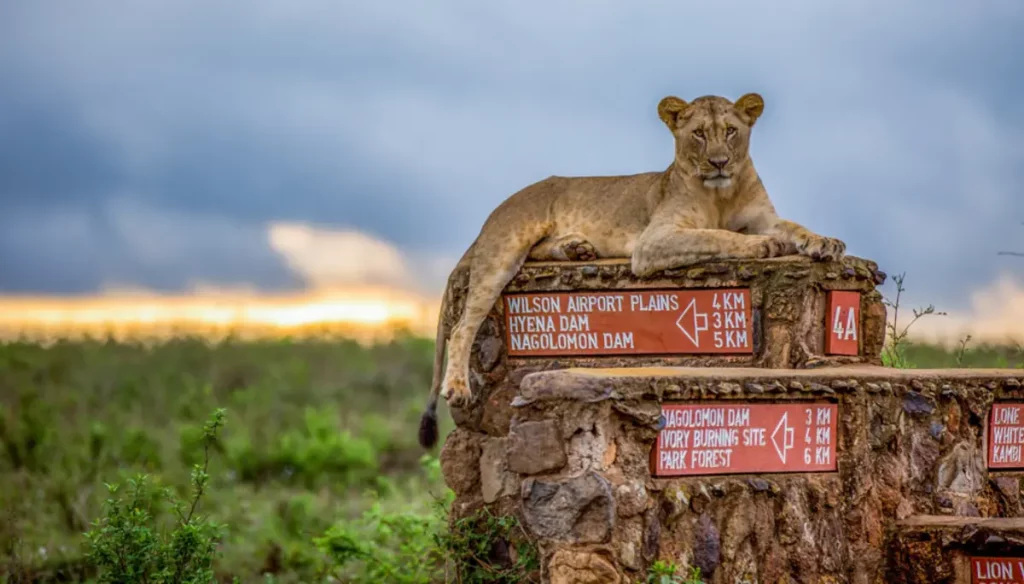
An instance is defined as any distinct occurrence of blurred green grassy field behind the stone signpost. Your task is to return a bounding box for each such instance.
[0,329,1024,583]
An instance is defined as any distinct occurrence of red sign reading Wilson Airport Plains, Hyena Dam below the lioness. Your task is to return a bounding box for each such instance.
[505,288,754,357]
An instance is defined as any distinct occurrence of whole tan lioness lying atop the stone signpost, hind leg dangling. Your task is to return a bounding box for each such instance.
[420,93,846,448]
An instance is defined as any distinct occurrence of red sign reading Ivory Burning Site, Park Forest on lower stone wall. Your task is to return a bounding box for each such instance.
[652,403,839,476]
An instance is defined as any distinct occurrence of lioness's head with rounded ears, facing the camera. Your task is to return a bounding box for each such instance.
[657,93,765,189]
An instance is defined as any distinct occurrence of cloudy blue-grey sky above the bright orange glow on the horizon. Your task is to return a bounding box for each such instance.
[0,0,1024,336]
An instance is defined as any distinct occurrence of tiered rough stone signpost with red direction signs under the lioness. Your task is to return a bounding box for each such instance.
[441,257,1024,584]
